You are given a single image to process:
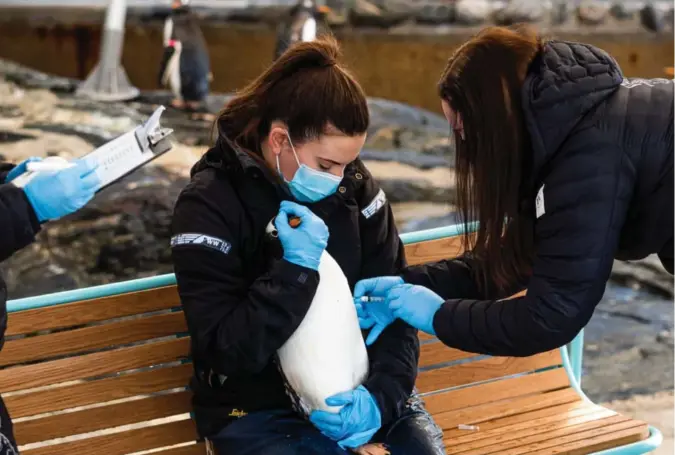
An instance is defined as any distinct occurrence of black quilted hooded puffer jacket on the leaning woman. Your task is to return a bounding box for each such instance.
[404,41,674,356]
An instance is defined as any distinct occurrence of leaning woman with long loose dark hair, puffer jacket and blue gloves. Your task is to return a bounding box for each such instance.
[355,27,674,356]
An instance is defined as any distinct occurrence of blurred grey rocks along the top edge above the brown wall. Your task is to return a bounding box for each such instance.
[5,0,673,32]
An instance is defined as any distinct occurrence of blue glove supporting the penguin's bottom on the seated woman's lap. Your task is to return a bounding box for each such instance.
[309,386,382,449]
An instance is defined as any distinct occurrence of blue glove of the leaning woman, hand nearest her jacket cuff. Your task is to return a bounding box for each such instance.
[387,284,444,336]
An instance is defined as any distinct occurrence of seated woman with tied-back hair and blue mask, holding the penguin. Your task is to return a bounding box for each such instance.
[171,38,443,455]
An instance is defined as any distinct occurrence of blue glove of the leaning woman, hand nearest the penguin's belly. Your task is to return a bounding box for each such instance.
[354,276,404,346]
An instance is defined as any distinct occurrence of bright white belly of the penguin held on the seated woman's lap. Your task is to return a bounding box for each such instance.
[278,251,368,414]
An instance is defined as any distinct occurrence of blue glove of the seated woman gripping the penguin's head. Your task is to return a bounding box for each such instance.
[274,201,328,270]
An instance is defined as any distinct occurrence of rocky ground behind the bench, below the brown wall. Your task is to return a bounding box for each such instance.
[0,56,673,434]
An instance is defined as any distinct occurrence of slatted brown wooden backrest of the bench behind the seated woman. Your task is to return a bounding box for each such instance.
[0,233,568,455]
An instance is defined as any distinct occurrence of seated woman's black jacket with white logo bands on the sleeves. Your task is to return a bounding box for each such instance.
[172,142,419,437]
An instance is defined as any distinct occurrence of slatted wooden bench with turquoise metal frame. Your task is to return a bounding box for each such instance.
[0,226,660,455]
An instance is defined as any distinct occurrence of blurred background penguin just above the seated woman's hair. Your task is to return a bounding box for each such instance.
[274,0,331,60]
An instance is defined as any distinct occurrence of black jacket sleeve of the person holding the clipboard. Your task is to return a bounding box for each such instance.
[0,163,40,349]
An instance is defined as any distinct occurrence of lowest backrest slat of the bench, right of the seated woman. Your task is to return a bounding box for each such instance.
[424,368,569,415]
